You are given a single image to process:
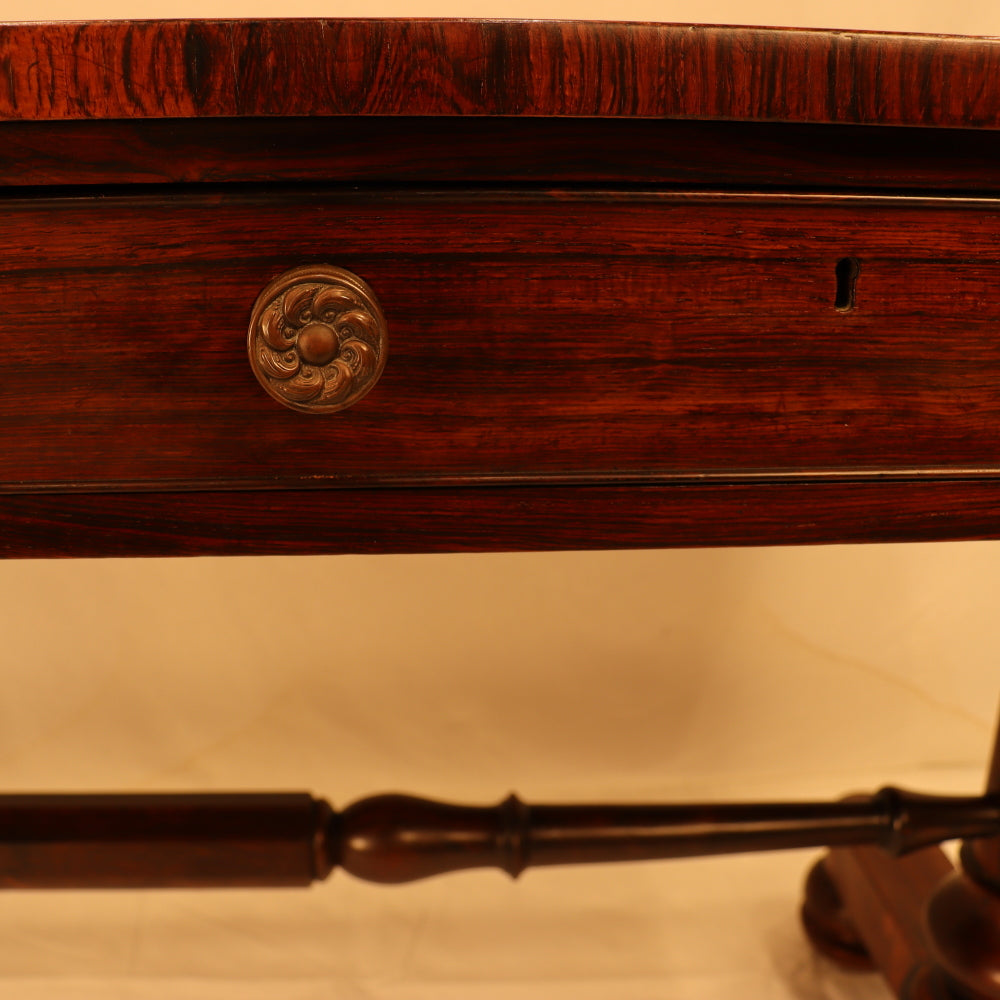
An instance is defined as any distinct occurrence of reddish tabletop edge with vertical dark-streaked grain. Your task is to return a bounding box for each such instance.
[0,19,1000,128]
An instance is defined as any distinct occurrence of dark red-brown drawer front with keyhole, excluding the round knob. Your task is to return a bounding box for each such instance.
[0,191,1000,492]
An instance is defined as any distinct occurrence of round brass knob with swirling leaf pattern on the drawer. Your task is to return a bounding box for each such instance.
[247,264,388,413]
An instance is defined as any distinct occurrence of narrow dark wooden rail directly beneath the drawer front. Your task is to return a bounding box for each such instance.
[0,476,1000,559]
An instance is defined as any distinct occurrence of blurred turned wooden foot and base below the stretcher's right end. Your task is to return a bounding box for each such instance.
[802,847,1000,1000]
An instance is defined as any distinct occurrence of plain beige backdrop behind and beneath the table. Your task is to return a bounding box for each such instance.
[0,0,1000,1000]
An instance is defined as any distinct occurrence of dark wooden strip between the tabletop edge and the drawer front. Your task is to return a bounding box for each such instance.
[0,116,1000,192]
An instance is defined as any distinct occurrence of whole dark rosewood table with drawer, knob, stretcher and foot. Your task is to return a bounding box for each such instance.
[0,20,1000,998]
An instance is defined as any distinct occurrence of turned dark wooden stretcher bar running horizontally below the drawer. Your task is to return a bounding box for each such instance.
[0,788,1000,889]
